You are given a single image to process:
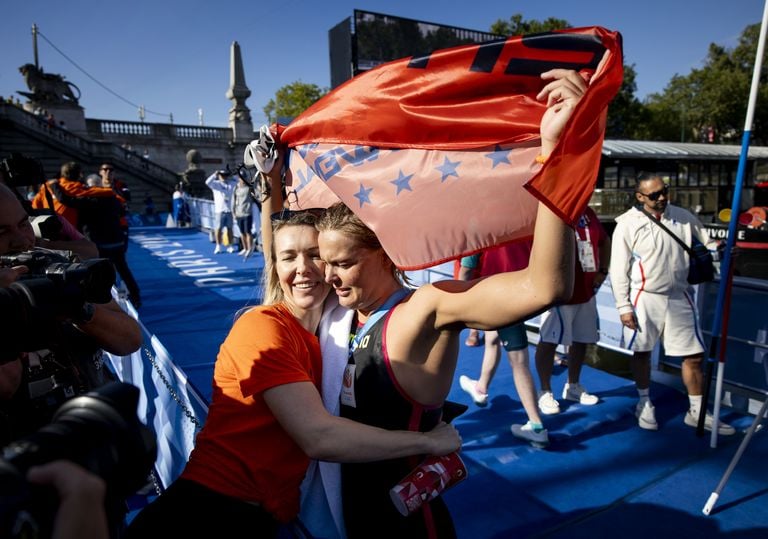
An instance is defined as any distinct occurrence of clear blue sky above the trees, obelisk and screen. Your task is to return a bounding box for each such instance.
[0,0,763,127]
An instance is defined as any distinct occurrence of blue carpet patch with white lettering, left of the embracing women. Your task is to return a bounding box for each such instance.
[128,227,264,401]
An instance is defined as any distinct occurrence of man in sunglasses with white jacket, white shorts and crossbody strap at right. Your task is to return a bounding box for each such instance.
[609,174,736,435]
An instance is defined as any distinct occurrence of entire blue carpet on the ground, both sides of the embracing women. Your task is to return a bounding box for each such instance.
[128,227,768,539]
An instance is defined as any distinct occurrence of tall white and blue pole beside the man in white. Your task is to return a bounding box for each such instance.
[703,0,768,448]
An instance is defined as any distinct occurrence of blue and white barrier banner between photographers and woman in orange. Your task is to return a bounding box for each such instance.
[105,299,208,489]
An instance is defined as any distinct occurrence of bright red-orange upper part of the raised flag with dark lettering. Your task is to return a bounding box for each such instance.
[281,27,622,150]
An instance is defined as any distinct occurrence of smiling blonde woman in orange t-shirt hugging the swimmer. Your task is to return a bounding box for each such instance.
[127,206,461,539]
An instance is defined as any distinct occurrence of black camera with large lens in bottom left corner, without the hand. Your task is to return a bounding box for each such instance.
[0,382,157,537]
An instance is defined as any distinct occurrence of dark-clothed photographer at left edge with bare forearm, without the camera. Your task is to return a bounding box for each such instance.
[0,184,142,443]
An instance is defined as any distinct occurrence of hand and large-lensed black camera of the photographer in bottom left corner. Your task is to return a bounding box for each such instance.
[0,382,157,539]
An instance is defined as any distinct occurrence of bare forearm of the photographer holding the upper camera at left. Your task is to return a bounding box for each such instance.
[73,300,142,356]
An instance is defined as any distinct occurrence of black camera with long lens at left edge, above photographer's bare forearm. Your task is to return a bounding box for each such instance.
[0,248,115,363]
